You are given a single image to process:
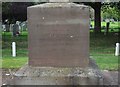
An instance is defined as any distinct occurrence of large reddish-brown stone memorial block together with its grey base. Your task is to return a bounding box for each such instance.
[8,3,103,85]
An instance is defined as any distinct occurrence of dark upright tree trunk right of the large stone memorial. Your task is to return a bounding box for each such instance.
[94,2,101,33]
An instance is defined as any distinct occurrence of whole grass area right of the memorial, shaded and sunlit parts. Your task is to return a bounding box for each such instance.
[90,33,119,70]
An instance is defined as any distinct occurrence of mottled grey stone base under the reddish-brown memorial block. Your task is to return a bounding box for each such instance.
[8,60,103,85]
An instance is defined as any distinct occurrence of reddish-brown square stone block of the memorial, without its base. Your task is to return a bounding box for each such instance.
[28,3,89,67]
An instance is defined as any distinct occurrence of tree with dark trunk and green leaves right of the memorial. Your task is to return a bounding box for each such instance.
[83,2,120,33]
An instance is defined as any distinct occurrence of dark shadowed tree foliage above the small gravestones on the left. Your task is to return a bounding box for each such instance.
[2,2,35,23]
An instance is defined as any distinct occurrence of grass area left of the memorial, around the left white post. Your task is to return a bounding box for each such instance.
[1,32,28,68]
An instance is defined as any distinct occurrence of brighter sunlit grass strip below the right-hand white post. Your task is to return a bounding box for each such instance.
[93,54,118,70]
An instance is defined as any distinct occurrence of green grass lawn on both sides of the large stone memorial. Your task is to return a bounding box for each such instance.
[0,25,118,70]
